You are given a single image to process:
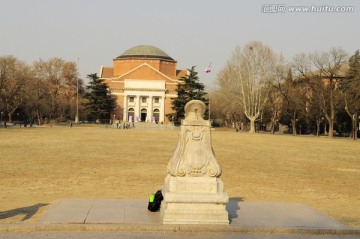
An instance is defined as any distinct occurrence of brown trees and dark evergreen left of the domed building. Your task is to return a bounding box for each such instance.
[0,56,115,125]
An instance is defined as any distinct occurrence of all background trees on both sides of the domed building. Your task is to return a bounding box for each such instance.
[0,41,360,138]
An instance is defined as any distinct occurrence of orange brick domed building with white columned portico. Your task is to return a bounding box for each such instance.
[99,45,187,123]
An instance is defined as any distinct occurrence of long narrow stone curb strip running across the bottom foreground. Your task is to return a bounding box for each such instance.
[0,224,360,236]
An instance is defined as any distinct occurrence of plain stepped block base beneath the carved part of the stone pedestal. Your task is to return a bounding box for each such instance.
[161,175,229,225]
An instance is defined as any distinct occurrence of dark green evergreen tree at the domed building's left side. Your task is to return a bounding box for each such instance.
[85,73,115,120]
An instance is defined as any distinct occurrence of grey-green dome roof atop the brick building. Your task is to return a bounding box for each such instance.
[117,45,174,60]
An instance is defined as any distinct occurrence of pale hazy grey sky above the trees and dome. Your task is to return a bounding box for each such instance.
[0,0,360,90]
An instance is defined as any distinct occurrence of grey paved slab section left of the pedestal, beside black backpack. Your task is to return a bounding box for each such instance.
[39,199,162,225]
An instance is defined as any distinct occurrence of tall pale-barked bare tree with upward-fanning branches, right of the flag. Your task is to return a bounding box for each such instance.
[218,41,279,133]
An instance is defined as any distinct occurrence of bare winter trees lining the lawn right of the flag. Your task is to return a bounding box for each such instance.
[210,41,360,137]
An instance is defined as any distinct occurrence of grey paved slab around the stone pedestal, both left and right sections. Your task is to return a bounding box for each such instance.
[39,199,350,229]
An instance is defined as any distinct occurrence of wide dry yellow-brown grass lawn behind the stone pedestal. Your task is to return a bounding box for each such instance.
[0,127,360,227]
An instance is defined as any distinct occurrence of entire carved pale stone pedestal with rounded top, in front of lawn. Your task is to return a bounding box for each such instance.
[161,100,229,224]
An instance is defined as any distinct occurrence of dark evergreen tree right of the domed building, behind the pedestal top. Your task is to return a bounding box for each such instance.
[167,66,208,123]
